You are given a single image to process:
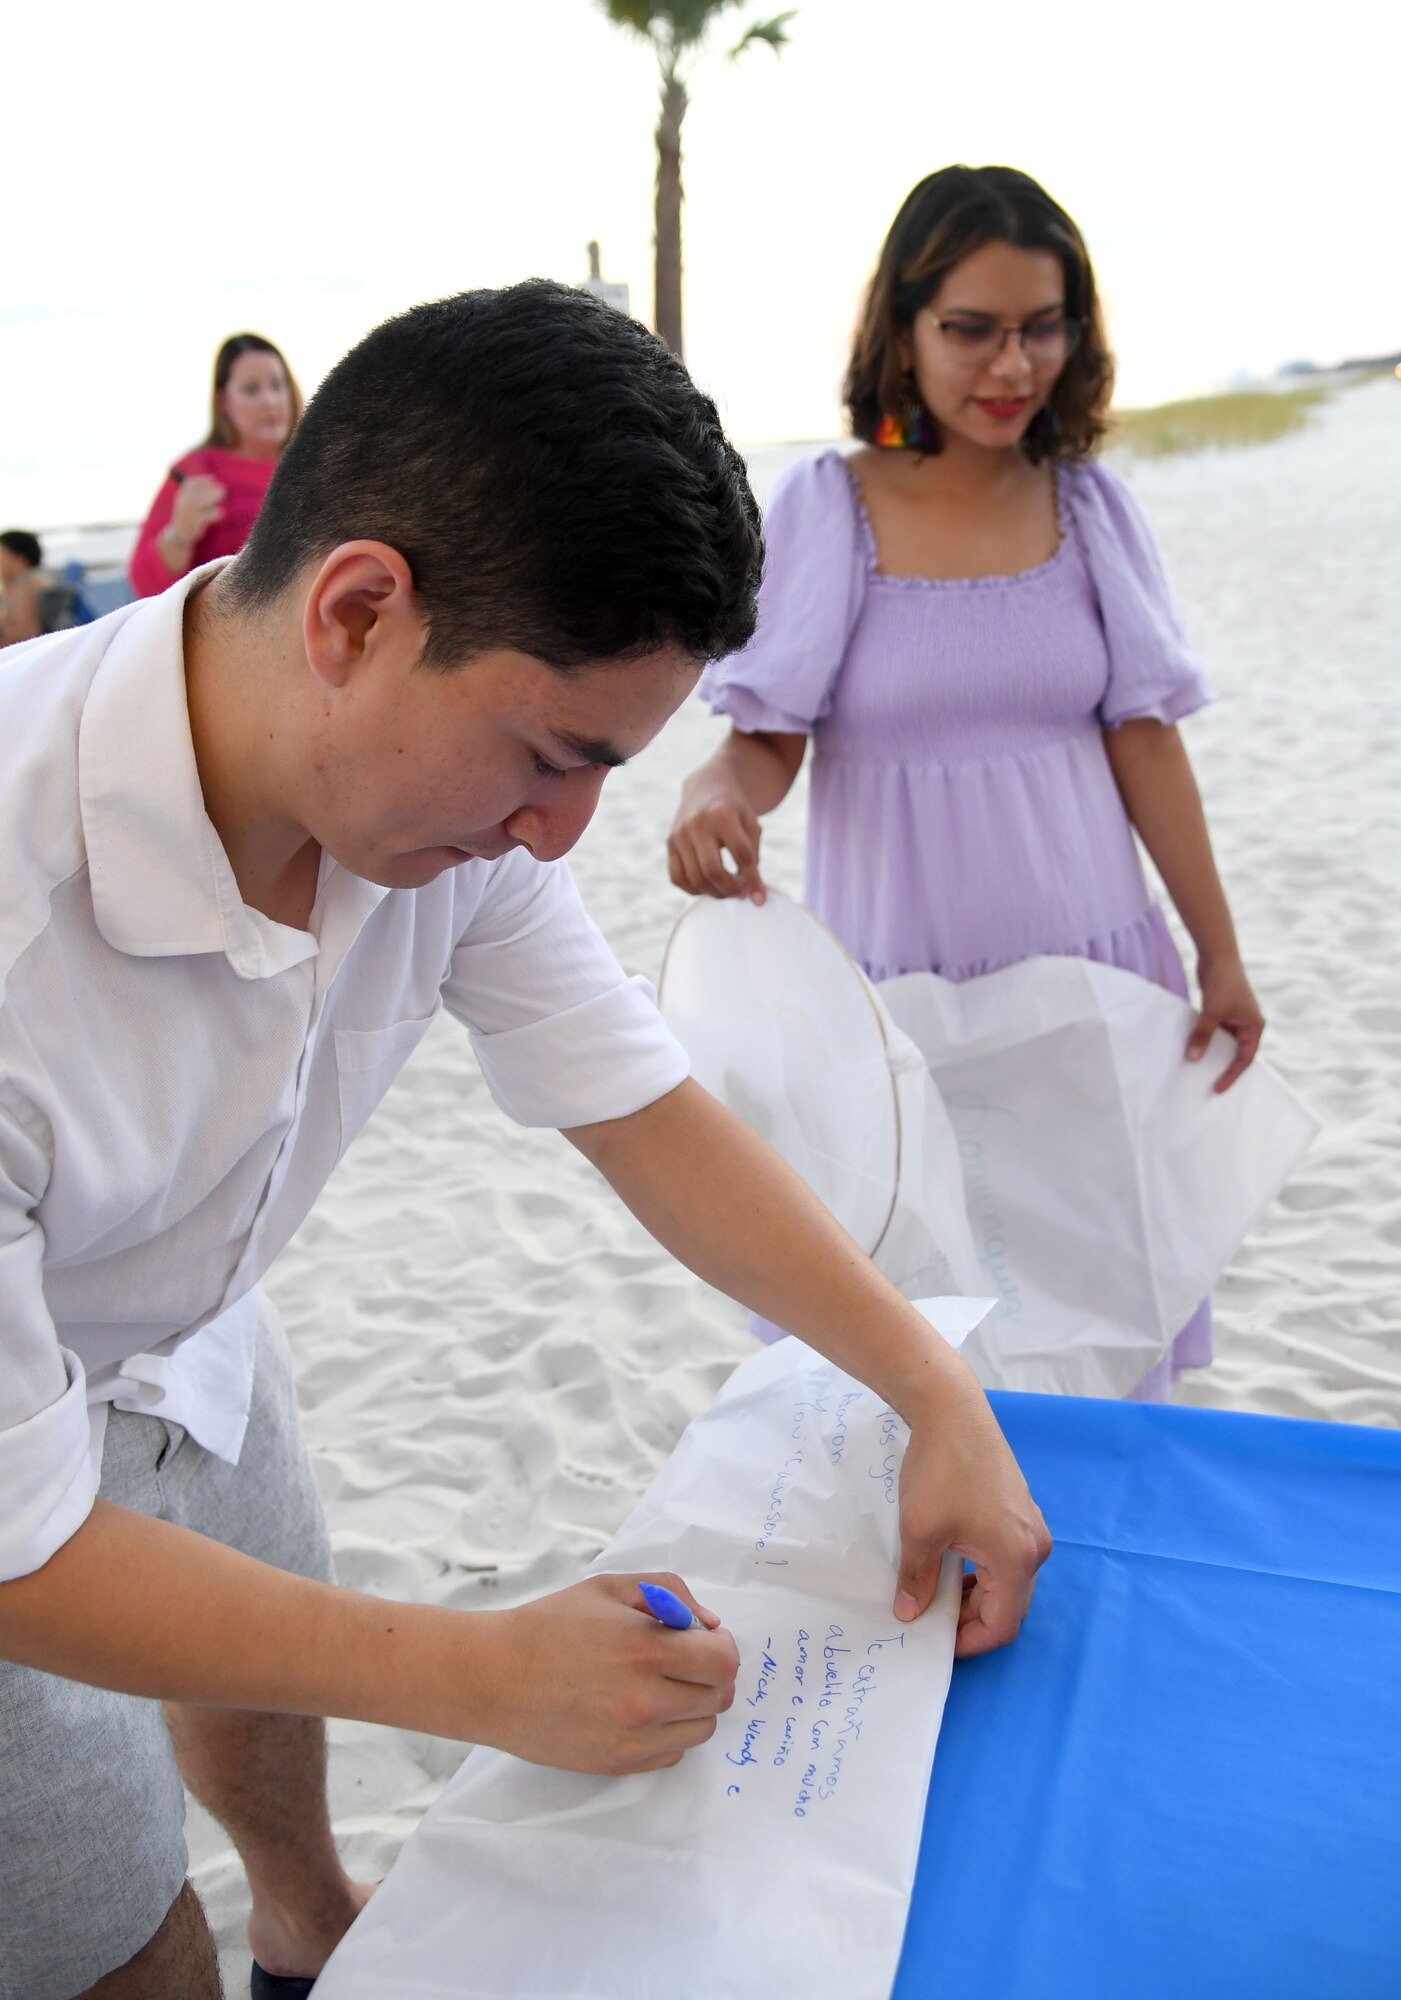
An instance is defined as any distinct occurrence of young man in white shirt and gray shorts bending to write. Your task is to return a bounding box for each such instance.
[0,282,1049,2000]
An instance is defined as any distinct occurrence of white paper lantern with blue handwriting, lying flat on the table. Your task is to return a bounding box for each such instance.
[316,1336,972,2000]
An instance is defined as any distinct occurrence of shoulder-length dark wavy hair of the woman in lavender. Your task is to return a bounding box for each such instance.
[845,166,1115,464]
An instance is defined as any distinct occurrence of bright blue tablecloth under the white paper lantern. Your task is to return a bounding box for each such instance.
[893,1394,1401,2000]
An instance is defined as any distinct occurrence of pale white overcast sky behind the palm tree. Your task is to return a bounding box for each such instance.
[0,0,1401,526]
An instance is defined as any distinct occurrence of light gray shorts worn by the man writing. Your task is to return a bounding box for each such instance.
[0,1300,330,2000]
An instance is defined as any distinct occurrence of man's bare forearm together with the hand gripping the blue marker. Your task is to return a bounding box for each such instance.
[0,1500,739,1776]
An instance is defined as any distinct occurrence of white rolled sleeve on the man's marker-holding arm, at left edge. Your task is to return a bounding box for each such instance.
[0,1086,96,1582]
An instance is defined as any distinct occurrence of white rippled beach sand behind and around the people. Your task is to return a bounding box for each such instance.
[190,380,1401,1992]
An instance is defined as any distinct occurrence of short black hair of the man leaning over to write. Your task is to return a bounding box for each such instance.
[226,278,763,670]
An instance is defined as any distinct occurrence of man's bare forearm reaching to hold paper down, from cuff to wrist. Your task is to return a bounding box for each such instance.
[566,1082,977,1420]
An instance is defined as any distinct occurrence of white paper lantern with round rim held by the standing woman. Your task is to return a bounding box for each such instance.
[660,894,1317,1396]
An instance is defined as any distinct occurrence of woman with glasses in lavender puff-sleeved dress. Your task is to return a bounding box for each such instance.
[668,166,1263,1398]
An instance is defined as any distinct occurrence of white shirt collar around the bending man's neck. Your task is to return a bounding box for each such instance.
[78,562,386,980]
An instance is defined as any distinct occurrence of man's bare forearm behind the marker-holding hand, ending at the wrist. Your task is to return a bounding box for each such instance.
[0,1500,496,1740]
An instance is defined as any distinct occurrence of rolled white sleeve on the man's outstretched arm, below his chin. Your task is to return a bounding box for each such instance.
[442,848,688,1128]
